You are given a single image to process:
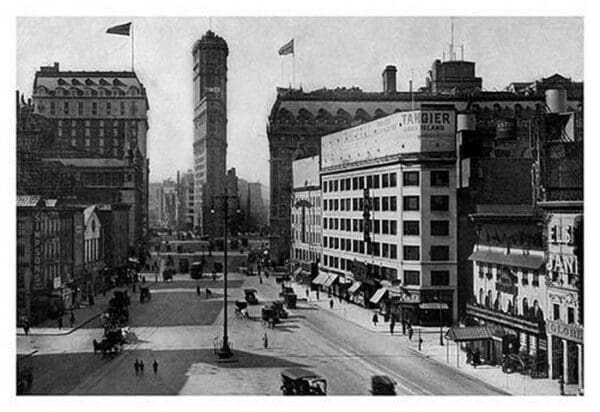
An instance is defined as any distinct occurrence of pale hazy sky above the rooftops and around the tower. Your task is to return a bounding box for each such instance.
[17,17,583,185]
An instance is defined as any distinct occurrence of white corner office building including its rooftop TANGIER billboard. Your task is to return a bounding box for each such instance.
[321,106,457,323]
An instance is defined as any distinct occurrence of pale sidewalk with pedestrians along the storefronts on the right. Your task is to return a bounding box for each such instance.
[292,283,577,396]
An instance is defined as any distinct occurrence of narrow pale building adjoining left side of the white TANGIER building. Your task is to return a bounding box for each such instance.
[290,156,323,271]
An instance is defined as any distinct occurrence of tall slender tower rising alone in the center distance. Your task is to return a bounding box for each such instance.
[192,30,229,236]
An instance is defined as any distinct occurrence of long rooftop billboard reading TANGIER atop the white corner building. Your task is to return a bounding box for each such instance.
[321,109,456,168]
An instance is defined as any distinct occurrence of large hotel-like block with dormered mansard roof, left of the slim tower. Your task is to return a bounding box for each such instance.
[33,63,149,247]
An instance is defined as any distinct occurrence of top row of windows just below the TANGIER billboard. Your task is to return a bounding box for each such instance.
[323,170,450,193]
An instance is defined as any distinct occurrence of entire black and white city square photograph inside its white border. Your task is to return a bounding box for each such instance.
[4,0,596,400]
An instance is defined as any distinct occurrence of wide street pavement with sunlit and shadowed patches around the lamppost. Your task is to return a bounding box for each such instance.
[18,274,502,395]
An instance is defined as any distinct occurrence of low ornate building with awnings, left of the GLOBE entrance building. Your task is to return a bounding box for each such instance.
[466,204,548,374]
